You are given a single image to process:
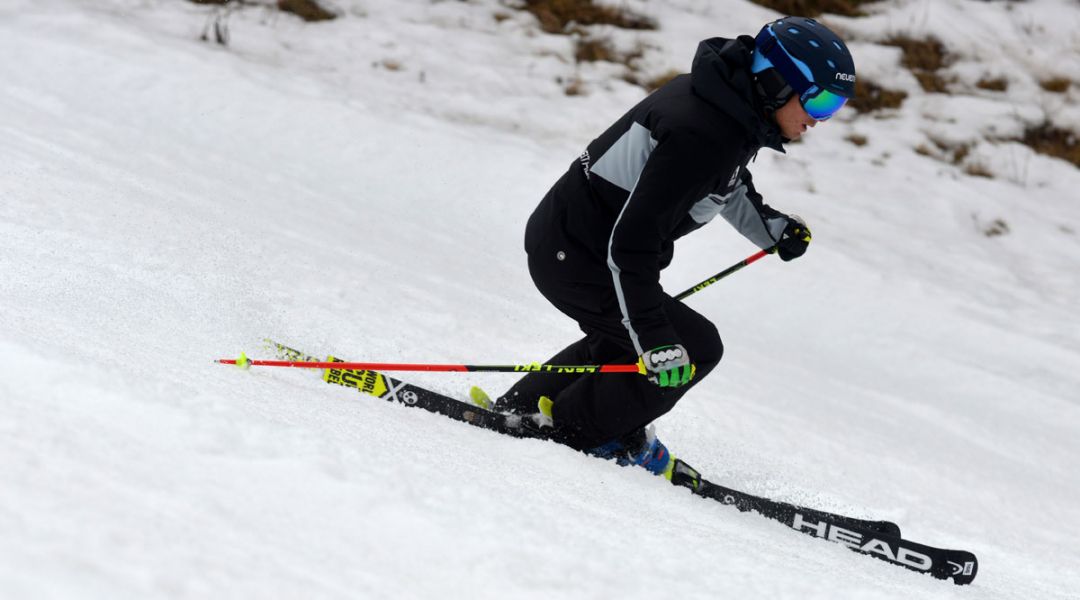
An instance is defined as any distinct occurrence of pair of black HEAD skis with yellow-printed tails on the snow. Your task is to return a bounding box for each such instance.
[266,340,978,585]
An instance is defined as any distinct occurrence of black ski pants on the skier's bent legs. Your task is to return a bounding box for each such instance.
[497,243,724,450]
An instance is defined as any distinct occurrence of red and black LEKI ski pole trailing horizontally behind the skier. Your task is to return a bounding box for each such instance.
[215,354,642,373]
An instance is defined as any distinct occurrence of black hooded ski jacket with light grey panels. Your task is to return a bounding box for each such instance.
[525,36,787,354]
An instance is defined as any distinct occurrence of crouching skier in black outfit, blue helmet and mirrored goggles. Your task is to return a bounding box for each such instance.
[494,16,855,479]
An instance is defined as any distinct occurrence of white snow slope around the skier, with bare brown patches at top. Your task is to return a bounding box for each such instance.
[0,0,1080,599]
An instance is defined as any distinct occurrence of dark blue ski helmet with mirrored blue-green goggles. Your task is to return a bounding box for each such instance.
[751,16,855,121]
